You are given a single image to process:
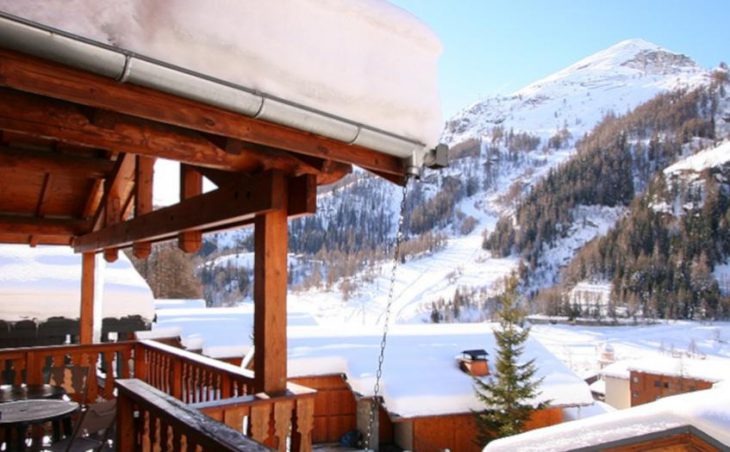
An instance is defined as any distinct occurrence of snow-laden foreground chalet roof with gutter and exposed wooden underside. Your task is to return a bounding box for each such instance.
[0,0,445,249]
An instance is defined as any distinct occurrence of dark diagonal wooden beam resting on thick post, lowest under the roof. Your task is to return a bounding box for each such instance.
[74,173,285,253]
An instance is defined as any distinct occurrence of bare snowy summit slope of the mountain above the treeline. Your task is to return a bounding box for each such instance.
[442,39,709,144]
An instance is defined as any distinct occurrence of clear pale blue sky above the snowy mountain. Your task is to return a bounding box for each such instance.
[391,0,730,118]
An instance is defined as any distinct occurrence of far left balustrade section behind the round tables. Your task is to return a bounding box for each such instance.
[0,342,134,402]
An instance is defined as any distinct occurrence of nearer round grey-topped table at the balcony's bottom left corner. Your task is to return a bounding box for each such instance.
[0,399,79,450]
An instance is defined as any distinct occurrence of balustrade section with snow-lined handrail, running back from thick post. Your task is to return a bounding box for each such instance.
[134,340,254,403]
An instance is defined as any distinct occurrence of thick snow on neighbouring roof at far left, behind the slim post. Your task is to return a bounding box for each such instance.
[0,245,153,322]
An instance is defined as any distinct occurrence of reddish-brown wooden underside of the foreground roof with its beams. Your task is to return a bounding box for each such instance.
[0,49,406,254]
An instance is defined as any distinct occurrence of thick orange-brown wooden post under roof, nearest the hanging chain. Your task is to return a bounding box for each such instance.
[254,173,287,394]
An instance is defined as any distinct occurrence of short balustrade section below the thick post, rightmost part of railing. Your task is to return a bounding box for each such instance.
[191,383,316,452]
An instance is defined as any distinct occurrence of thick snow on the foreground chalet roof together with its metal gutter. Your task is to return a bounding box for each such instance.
[0,0,443,161]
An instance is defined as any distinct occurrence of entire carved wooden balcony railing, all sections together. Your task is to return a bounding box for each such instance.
[0,341,315,451]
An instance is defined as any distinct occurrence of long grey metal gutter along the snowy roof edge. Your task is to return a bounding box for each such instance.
[0,11,447,175]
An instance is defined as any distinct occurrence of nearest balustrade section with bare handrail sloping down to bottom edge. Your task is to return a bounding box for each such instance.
[116,379,268,452]
